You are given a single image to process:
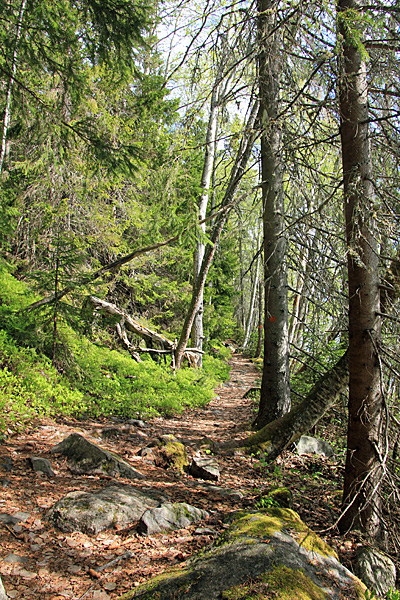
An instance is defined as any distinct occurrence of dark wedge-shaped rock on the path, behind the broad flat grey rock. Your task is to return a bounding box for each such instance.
[51,433,143,479]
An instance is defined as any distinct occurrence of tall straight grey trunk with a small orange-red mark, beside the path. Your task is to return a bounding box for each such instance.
[254,0,291,429]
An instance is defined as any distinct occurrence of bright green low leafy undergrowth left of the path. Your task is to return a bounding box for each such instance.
[0,264,229,436]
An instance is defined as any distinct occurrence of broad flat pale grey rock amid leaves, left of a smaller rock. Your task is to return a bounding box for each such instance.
[46,485,166,534]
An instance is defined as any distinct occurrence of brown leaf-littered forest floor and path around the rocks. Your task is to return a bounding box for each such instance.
[0,355,360,600]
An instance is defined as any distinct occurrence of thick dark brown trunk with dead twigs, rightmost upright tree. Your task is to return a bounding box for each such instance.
[338,0,384,538]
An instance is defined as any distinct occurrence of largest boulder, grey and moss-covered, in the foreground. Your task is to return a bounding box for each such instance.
[126,508,366,600]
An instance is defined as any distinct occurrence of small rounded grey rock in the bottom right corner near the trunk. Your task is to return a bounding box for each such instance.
[354,548,396,597]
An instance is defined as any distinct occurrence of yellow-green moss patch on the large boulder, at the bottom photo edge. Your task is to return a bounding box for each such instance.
[222,565,327,600]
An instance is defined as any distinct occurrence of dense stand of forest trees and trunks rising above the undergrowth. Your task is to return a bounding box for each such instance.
[0,0,400,556]
